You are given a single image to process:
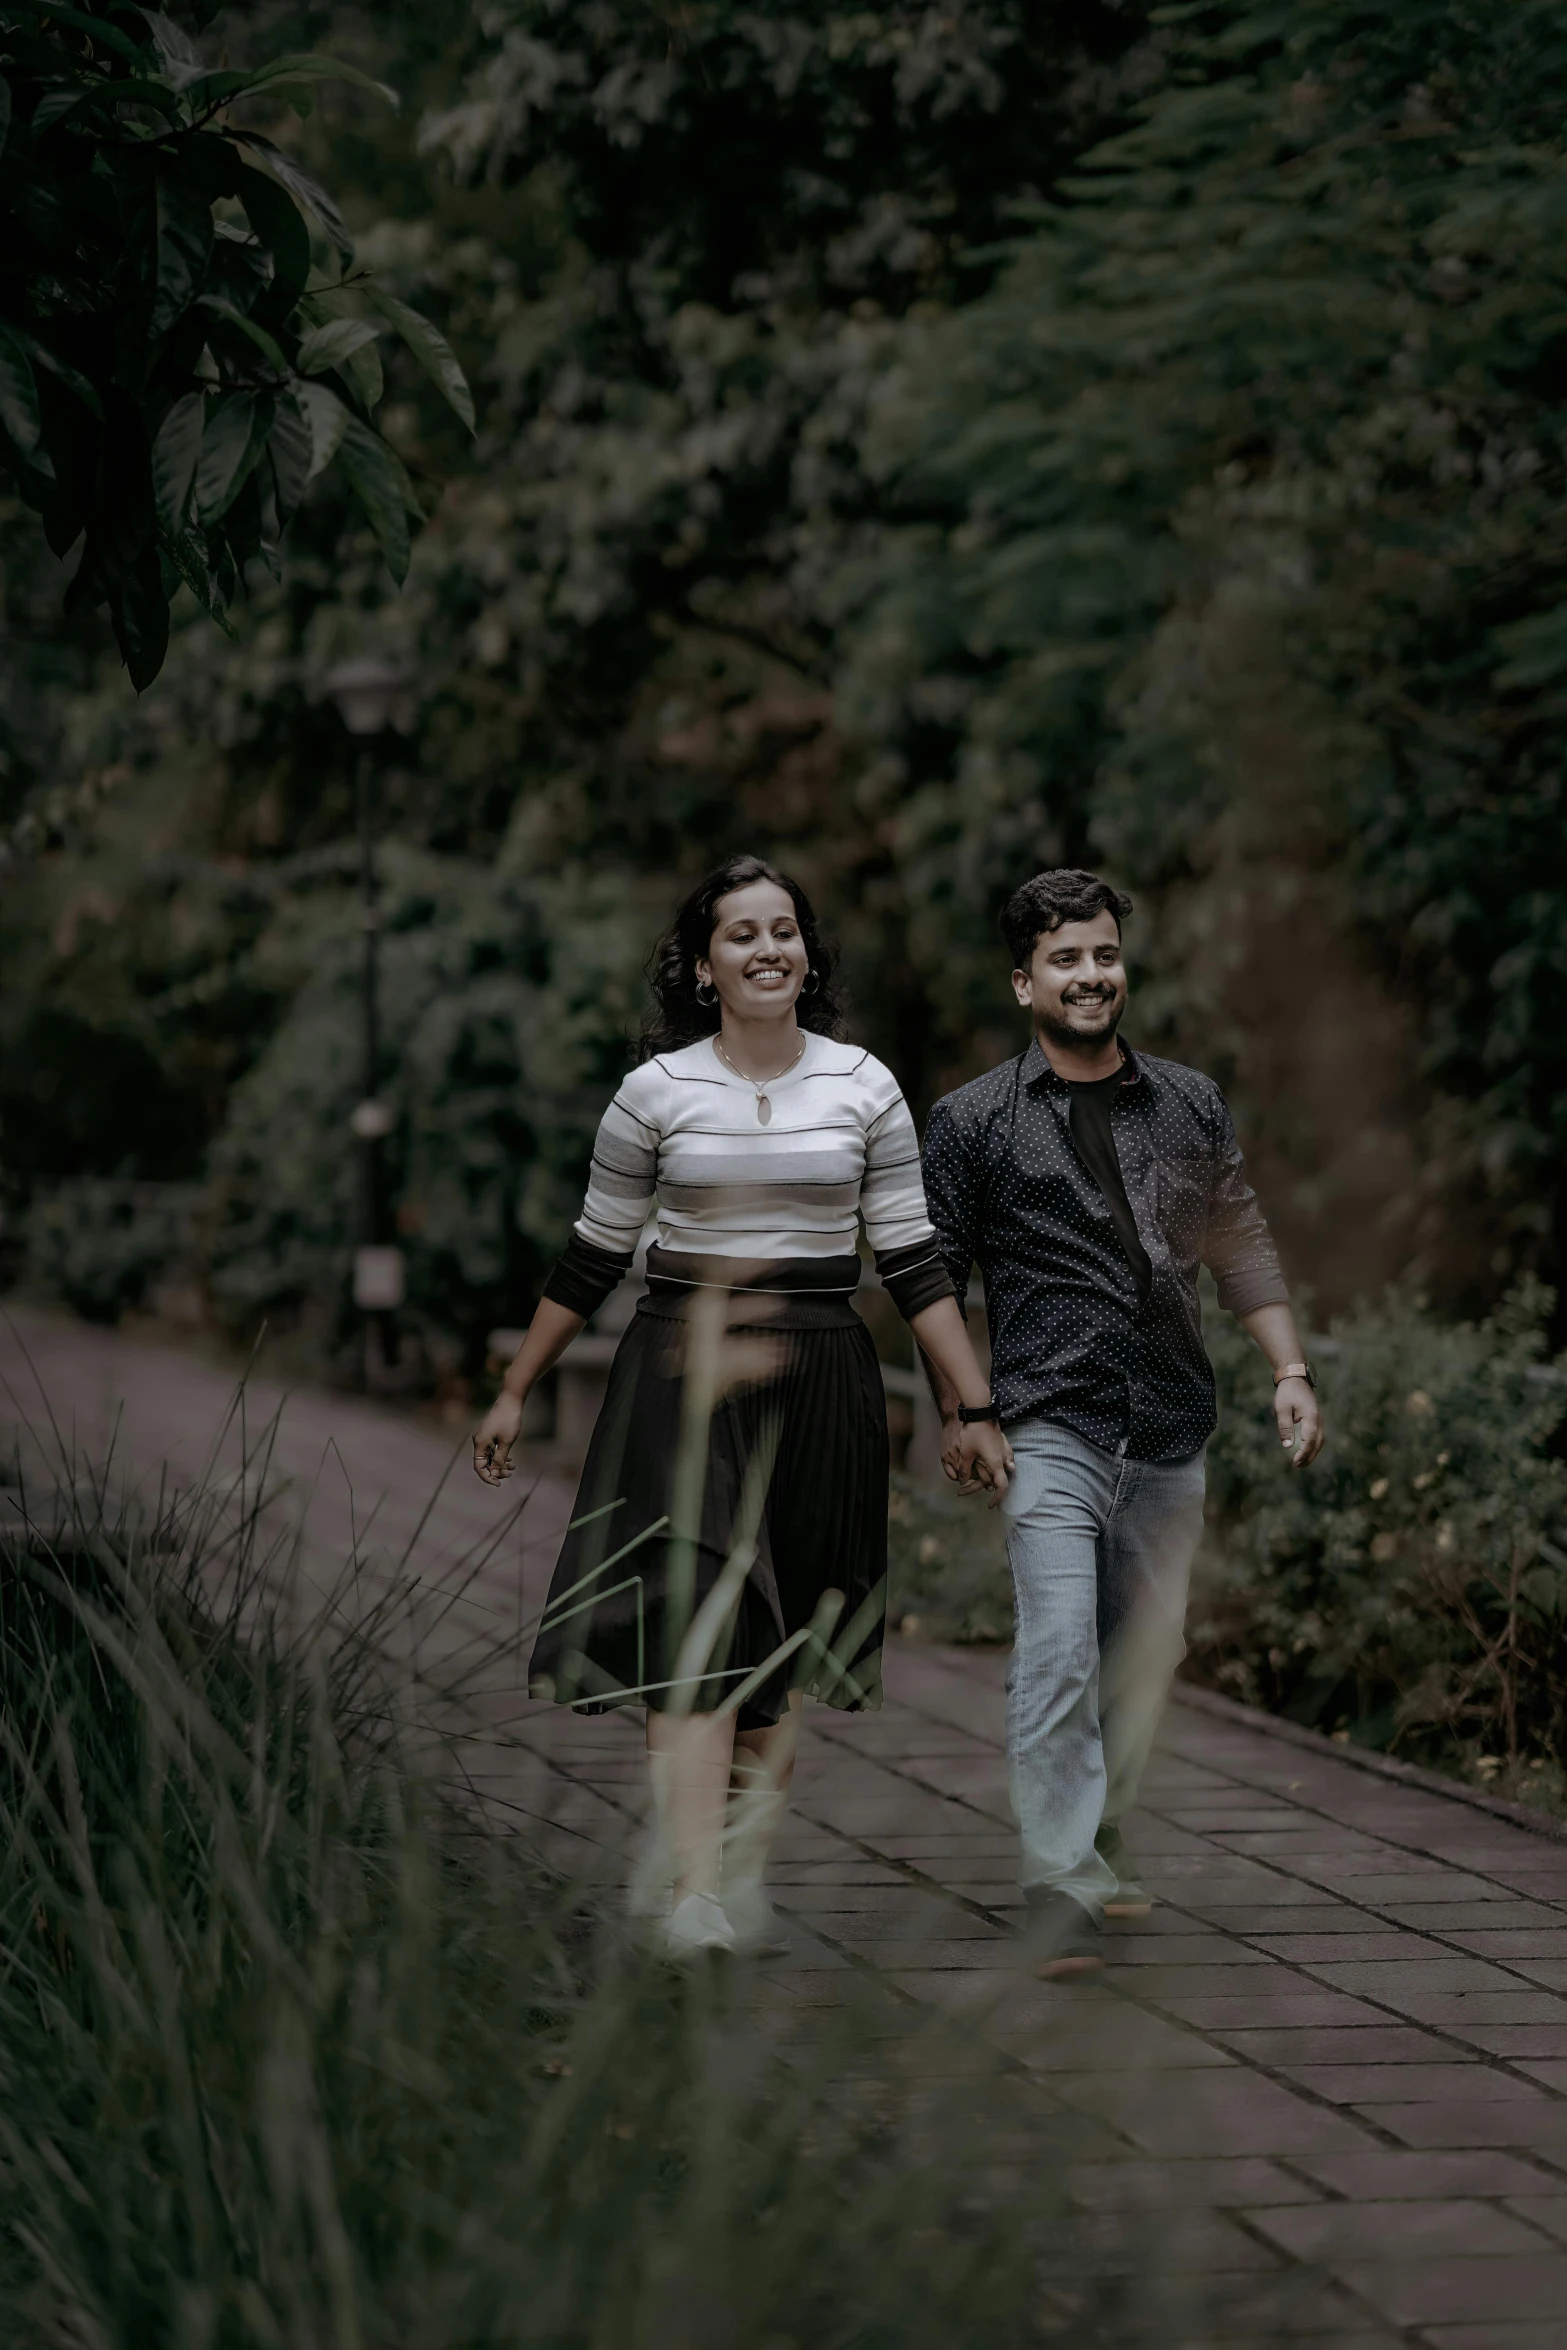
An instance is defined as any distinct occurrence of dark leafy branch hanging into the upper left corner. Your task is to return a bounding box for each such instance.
[0,0,472,689]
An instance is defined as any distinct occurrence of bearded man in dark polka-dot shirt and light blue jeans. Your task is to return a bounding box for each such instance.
[926,872,1323,1974]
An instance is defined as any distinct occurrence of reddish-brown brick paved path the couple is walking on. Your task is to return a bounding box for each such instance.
[0,1316,1567,2350]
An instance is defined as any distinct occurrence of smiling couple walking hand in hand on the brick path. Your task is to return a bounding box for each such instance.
[475,858,1323,1974]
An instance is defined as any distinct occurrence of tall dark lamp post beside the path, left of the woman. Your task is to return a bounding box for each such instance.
[327,656,404,1389]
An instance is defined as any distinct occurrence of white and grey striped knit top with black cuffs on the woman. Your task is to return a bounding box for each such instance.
[545,1034,951,1314]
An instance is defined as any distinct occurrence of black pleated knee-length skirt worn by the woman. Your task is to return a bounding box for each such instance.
[529,1260,888,1730]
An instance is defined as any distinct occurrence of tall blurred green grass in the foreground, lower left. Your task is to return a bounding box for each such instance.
[0,1400,1221,2350]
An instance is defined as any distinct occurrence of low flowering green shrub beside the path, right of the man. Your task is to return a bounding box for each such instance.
[1191,1285,1567,1770]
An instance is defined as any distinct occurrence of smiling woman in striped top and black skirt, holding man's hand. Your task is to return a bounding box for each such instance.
[475,858,1010,1958]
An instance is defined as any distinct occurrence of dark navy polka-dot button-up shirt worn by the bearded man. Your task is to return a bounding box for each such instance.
[926,1041,1287,1462]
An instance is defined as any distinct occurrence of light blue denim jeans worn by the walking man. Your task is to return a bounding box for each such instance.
[1001,1419,1203,1911]
